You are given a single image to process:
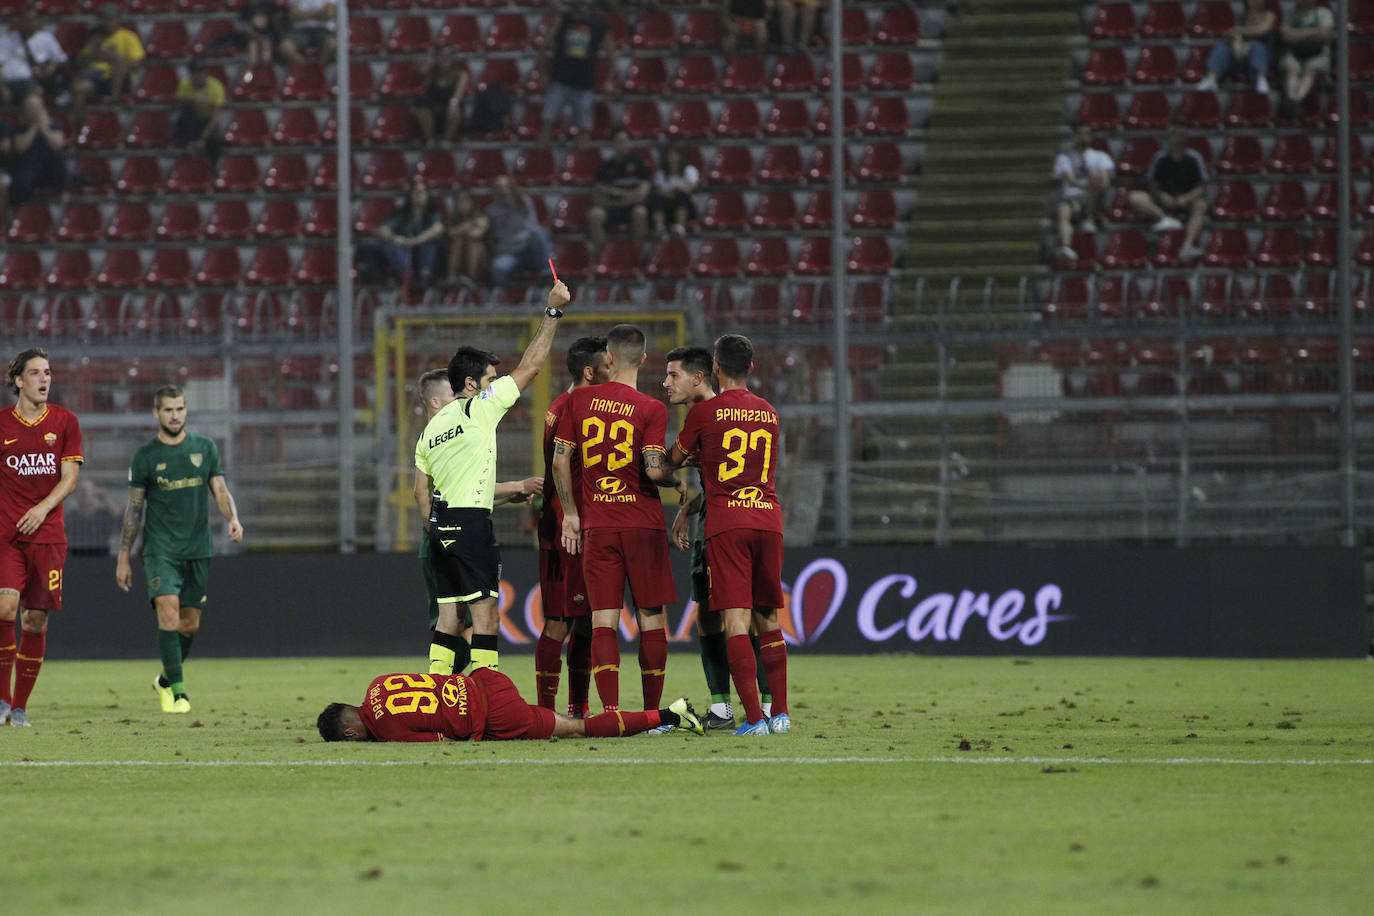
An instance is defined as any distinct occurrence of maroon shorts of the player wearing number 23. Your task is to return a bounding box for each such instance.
[583,527,677,611]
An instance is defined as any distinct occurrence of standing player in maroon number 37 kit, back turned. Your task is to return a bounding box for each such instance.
[665,334,791,735]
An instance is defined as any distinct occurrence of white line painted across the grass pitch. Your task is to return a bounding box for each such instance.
[0,757,1374,769]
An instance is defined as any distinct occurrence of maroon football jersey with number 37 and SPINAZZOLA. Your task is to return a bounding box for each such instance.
[677,389,782,537]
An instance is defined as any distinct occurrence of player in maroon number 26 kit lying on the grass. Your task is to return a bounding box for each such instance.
[315,667,705,742]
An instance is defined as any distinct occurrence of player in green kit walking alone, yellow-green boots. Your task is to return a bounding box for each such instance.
[114,385,243,713]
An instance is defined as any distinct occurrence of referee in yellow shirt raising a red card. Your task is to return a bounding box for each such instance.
[415,282,573,674]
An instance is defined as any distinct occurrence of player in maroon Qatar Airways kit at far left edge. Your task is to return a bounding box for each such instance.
[0,347,85,726]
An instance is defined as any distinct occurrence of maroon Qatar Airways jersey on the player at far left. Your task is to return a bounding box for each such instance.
[0,404,84,544]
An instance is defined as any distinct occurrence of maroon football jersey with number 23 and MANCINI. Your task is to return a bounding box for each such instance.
[555,382,668,531]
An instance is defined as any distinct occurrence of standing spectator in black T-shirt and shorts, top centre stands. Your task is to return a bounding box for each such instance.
[539,0,616,146]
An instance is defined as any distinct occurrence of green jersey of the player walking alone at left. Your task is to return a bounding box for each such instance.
[129,433,224,560]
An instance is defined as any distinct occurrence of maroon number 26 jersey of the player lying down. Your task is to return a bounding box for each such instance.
[357,674,486,742]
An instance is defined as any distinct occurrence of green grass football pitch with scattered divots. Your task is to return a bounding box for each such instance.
[0,652,1374,916]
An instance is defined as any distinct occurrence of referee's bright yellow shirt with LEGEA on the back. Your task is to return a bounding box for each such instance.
[415,375,519,511]
